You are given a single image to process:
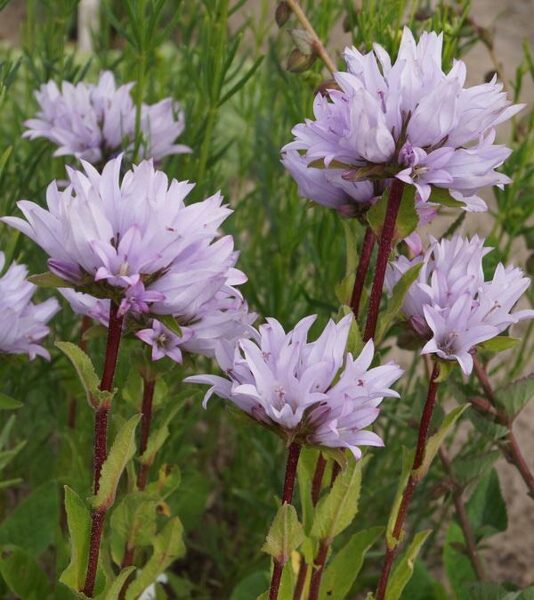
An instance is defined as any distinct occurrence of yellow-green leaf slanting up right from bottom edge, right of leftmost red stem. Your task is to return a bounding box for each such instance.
[126,517,185,600]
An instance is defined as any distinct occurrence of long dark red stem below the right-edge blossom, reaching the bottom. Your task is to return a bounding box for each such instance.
[375,362,439,600]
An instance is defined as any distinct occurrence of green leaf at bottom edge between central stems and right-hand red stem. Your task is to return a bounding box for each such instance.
[320,527,384,600]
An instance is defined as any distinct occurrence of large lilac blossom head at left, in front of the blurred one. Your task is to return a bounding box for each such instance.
[2,157,245,328]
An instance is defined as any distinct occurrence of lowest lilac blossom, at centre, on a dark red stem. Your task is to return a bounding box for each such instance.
[185,315,402,459]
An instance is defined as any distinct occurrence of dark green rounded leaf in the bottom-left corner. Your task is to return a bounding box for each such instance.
[0,546,48,600]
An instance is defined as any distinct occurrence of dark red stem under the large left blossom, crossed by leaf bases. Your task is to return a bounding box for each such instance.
[82,302,123,598]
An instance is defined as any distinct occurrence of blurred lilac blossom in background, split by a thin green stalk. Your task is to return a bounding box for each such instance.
[24,71,191,164]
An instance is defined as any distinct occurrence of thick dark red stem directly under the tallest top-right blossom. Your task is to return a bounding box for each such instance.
[363,179,404,342]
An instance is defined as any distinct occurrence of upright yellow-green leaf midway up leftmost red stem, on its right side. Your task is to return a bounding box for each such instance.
[91,415,141,510]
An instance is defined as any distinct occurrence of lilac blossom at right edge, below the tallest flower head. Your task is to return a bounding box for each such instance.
[386,236,534,375]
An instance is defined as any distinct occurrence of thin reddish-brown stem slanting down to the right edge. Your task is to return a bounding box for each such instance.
[473,356,534,498]
